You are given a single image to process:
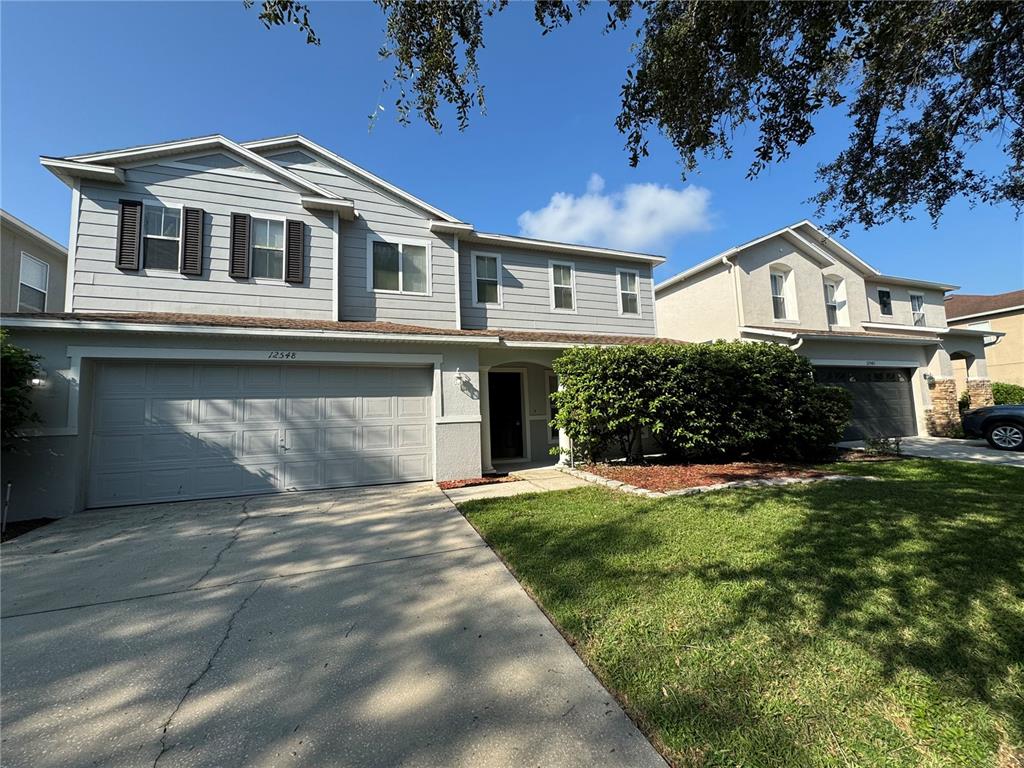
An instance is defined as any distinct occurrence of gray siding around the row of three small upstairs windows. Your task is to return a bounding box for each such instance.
[460,243,655,336]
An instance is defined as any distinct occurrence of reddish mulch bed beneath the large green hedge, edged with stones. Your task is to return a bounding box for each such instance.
[581,462,826,493]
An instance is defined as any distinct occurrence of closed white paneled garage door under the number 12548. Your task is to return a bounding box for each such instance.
[87,361,432,507]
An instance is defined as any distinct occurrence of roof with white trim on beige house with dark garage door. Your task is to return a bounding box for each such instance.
[654,224,957,294]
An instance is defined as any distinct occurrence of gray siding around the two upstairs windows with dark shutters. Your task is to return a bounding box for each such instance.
[73,156,334,319]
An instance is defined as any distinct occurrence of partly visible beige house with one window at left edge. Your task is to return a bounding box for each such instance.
[0,210,68,312]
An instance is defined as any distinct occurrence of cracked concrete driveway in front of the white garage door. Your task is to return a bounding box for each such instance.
[2,483,665,768]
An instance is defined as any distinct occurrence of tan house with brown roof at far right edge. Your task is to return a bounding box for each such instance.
[946,290,1024,386]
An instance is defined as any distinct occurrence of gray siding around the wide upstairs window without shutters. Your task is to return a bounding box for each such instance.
[267,151,456,328]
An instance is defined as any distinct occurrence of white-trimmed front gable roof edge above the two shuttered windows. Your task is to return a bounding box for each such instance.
[39,133,342,200]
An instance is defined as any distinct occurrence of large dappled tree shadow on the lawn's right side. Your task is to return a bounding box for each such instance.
[697,463,1024,733]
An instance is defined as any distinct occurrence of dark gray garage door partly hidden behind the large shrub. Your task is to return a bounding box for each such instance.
[814,367,918,440]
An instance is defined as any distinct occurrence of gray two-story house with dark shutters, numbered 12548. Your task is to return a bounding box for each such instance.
[4,135,664,517]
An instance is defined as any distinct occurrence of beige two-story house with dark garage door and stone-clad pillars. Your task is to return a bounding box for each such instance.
[654,221,991,439]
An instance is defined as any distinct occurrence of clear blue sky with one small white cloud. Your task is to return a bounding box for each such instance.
[0,0,1024,293]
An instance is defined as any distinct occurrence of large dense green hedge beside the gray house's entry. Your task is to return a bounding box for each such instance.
[554,342,850,461]
